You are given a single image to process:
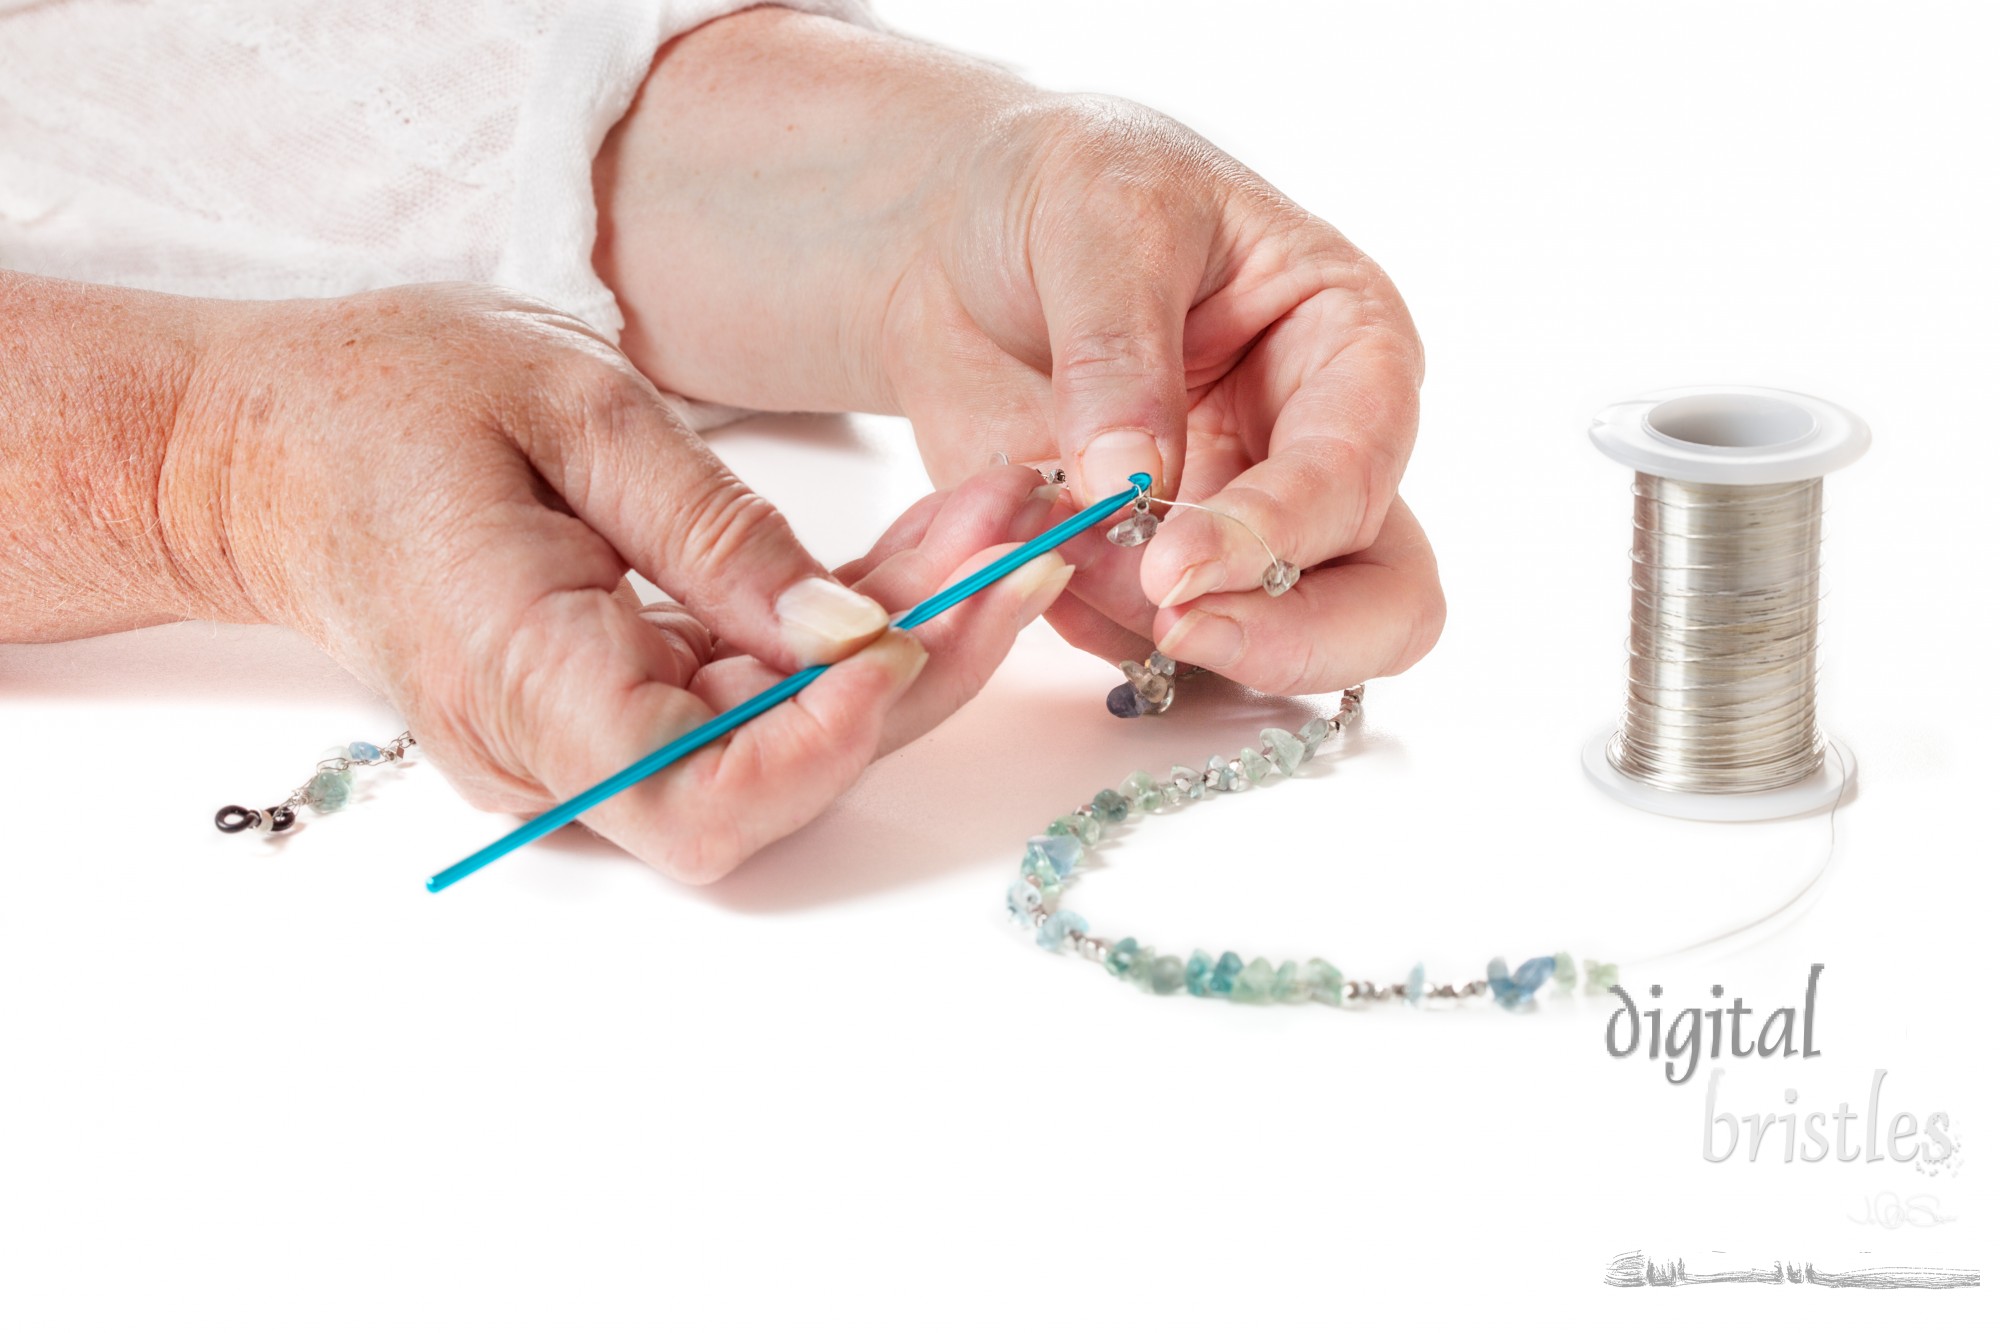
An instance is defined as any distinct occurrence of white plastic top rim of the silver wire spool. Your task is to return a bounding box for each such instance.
[1590,384,1870,486]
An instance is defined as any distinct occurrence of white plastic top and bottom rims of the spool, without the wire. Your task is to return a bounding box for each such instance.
[1584,384,1868,823]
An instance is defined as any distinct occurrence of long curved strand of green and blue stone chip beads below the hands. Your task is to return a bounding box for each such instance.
[1006,684,1618,1011]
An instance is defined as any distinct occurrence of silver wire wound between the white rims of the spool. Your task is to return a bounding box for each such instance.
[1608,472,1824,793]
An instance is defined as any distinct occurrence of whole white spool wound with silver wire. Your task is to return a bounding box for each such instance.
[1584,386,1868,821]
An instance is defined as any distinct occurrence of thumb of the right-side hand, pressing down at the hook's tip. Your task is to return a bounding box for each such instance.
[1036,232,1198,502]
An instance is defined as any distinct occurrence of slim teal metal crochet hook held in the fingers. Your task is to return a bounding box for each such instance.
[424,472,1152,893]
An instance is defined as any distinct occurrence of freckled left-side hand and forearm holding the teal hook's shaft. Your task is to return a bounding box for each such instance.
[0,274,1070,881]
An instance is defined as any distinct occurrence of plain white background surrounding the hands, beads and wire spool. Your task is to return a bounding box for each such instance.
[0,0,2000,1329]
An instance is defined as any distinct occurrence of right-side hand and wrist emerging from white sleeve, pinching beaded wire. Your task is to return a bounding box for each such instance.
[598,10,1444,691]
